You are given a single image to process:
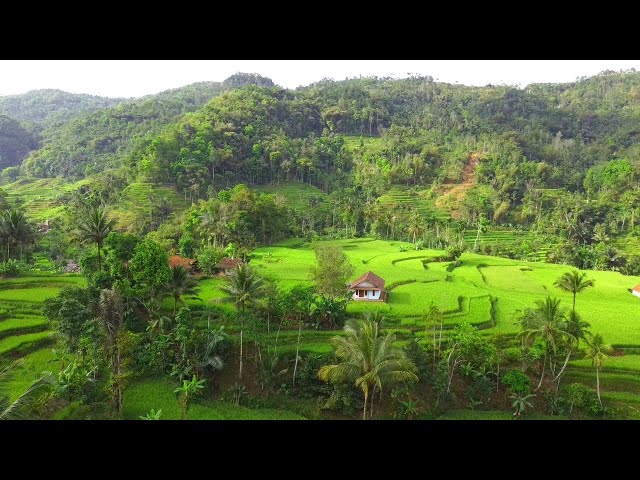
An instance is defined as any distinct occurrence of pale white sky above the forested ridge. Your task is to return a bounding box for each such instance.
[0,60,640,97]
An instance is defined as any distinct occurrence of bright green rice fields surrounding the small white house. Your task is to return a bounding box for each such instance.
[246,239,640,347]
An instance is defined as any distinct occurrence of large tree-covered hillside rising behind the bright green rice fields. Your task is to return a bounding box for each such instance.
[6,71,640,272]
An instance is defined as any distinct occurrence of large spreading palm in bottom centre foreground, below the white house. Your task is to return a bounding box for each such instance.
[318,319,418,420]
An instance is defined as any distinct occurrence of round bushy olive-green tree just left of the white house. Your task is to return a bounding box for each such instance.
[311,245,353,298]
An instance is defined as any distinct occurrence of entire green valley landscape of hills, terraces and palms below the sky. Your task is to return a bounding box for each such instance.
[0,62,640,425]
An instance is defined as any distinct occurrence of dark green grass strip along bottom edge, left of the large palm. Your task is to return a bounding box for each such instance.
[123,379,304,420]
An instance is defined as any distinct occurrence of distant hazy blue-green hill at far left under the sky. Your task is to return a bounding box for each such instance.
[0,89,124,132]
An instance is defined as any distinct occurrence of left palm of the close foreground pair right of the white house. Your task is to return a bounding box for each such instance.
[520,297,574,390]
